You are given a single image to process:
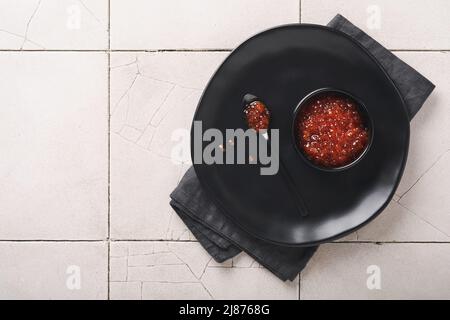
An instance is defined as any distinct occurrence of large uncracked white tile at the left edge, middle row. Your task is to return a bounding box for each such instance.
[0,52,108,239]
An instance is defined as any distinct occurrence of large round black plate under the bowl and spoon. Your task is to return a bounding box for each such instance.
[191,24,409,245]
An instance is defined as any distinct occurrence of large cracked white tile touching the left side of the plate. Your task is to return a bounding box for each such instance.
[111,52,227,240]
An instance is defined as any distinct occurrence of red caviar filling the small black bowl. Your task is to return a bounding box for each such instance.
[296,93,369,168]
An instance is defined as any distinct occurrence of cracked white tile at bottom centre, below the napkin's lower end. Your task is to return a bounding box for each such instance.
[111,241,298,299]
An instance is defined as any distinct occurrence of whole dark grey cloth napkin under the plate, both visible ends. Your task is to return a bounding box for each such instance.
[170,15,434,281]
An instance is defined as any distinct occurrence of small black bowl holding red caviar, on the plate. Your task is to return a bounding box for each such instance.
[292,88,373,172]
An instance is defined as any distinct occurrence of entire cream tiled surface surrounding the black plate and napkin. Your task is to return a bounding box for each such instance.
[0,0,450,299]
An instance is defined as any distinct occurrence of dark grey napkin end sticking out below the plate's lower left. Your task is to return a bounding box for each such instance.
[170,167,317,280]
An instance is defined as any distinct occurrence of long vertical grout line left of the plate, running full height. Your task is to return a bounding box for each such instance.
[107,0,111,300]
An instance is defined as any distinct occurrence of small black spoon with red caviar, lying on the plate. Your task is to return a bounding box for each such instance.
[242,93,308,217]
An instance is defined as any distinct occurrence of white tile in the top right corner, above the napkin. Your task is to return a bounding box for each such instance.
[301,0,450,50]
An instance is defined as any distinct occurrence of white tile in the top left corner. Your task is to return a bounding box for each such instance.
[0,0,108,50]
